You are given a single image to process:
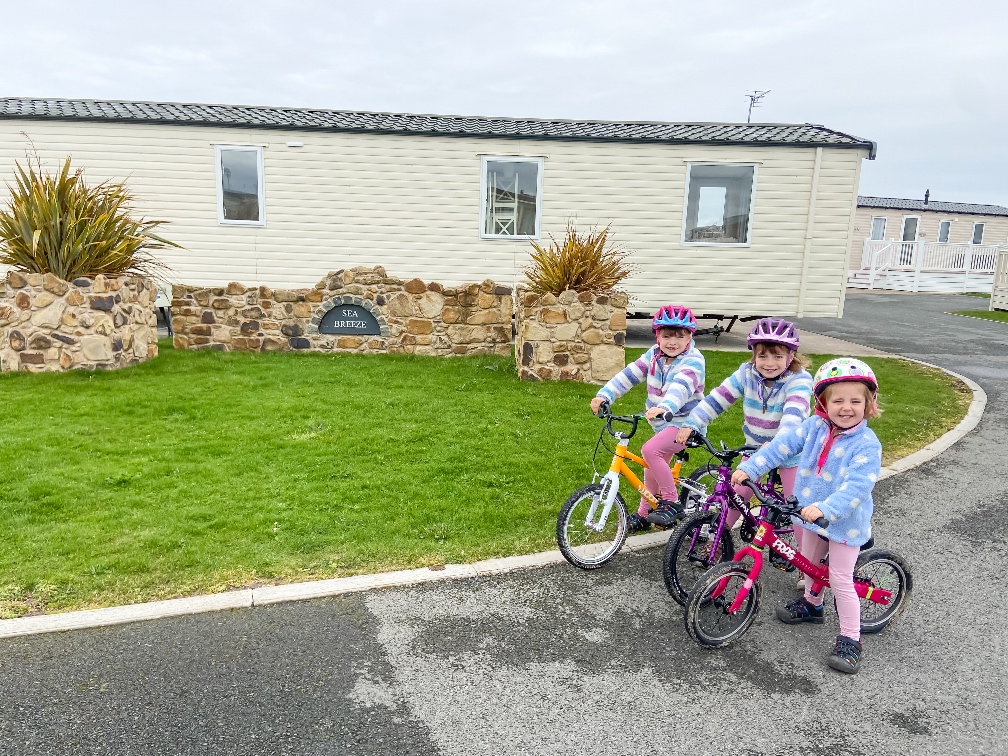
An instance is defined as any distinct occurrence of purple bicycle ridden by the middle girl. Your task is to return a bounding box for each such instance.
[661,430,794,606]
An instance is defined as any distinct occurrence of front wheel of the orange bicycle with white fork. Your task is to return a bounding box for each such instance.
[556,483,627,570]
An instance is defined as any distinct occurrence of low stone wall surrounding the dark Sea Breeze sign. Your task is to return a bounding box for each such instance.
[171,266,514,356]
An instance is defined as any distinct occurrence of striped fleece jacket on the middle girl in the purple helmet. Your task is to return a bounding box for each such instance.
[685,362,812,468]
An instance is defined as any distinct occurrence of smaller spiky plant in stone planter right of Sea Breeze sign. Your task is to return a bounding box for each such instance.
[525,222,633,294]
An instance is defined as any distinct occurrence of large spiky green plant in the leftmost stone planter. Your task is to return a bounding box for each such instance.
[0,157,178,280]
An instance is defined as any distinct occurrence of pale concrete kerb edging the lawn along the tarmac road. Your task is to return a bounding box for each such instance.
[0,357,987,638]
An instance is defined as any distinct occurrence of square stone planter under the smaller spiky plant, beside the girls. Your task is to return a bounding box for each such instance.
[514,287,627,383]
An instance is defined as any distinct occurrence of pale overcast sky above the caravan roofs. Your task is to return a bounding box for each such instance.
[7,0,1008,206]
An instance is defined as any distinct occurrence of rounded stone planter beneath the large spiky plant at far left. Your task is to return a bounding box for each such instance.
[0,271,157,372]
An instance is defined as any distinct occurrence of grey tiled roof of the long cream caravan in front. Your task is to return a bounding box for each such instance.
[0,97,875,152]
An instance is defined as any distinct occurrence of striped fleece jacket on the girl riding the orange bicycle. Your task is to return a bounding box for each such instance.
[597,341,707,432]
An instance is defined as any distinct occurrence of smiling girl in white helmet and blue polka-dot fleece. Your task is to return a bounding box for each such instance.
[732,357,882,673]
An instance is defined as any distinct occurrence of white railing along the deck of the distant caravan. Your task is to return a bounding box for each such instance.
[861,239,1000,291]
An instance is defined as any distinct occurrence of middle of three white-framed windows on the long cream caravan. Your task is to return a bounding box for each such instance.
[480,156,542,239]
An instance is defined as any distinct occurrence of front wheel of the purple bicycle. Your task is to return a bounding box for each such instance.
[661,509,735,606]
